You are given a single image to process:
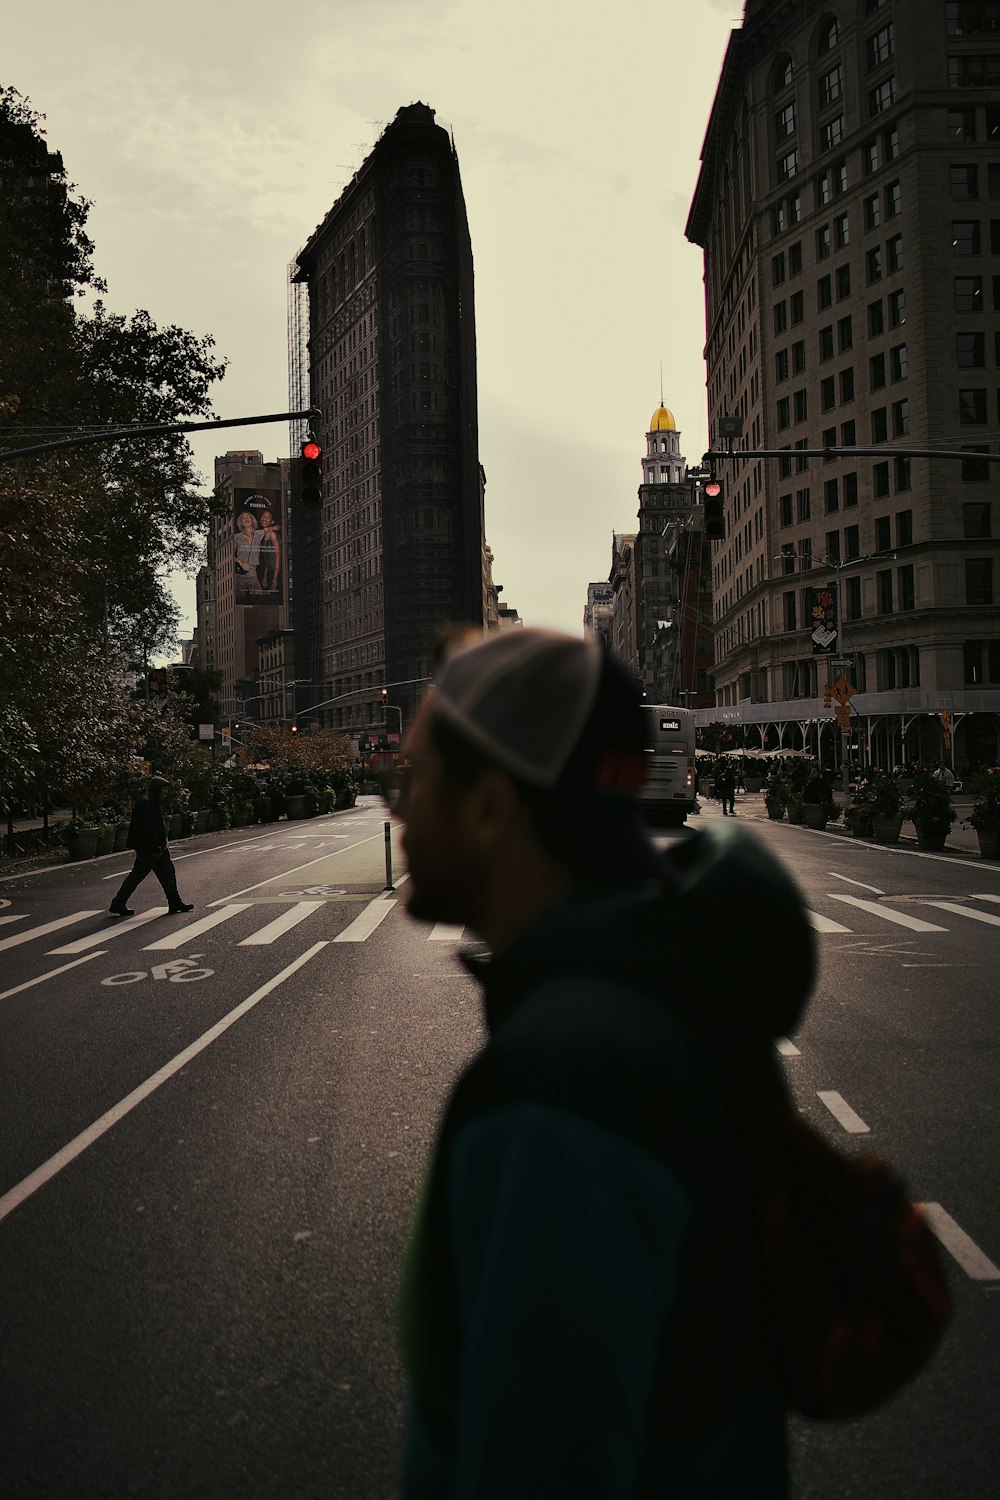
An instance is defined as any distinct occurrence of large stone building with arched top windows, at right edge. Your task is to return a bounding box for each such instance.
[687,0,1000,765]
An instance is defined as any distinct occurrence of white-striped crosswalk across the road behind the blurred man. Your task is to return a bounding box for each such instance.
[0,891,1000,957]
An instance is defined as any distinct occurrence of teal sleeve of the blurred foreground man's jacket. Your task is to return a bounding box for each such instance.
[448,1103,690,1500]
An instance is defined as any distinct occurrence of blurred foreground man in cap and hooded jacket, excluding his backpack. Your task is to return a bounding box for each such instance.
[397,630,814,1500]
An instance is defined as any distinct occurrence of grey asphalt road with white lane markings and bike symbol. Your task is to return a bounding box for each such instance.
[0,803,1000,1500]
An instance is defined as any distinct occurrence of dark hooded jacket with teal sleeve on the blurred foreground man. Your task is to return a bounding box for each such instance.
[402,827,814,1500]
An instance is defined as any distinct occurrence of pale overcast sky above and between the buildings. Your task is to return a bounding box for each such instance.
[0,0,742,633]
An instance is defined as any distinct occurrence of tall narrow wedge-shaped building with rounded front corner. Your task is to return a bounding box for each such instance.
[295,104,487,735]
